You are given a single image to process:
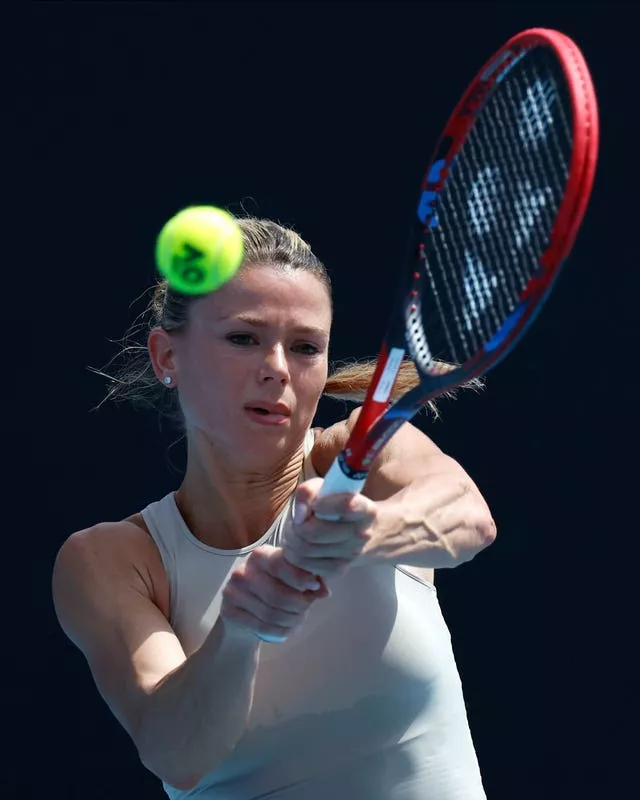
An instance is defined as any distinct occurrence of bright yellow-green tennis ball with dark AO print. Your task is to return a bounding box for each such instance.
[156,206,244,295]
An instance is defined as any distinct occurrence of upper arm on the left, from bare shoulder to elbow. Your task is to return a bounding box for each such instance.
[52,523,186,741]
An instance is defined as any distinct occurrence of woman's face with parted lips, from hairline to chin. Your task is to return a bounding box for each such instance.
[162,265,331,462]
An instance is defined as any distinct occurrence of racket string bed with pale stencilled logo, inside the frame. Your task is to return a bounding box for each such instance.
[418,47,572,369]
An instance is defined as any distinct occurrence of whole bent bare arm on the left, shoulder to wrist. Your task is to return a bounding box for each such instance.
[53,523,260,789]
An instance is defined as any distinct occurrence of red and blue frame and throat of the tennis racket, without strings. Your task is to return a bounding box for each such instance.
[322,28,599,494]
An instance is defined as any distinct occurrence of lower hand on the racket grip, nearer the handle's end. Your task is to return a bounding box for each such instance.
[220,545,330,642]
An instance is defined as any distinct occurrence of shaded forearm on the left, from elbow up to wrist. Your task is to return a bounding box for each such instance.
[136,618,260,789]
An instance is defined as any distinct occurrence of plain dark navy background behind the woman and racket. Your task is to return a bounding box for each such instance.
[16,0,639,800]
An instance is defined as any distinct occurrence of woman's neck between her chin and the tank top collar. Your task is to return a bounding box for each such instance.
[175,435,304,550]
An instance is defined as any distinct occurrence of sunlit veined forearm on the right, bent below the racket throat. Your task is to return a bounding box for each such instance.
[357,473,496,569]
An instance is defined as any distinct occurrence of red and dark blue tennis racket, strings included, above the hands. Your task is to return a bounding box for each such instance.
[320,28,598,506]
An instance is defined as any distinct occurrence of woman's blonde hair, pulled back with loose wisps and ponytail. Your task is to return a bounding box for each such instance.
[90,212,482,427]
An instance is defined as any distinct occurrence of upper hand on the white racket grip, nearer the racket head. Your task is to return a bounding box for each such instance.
[283,478,378,578]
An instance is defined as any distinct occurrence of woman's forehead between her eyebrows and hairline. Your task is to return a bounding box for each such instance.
[193,265,331,329]
